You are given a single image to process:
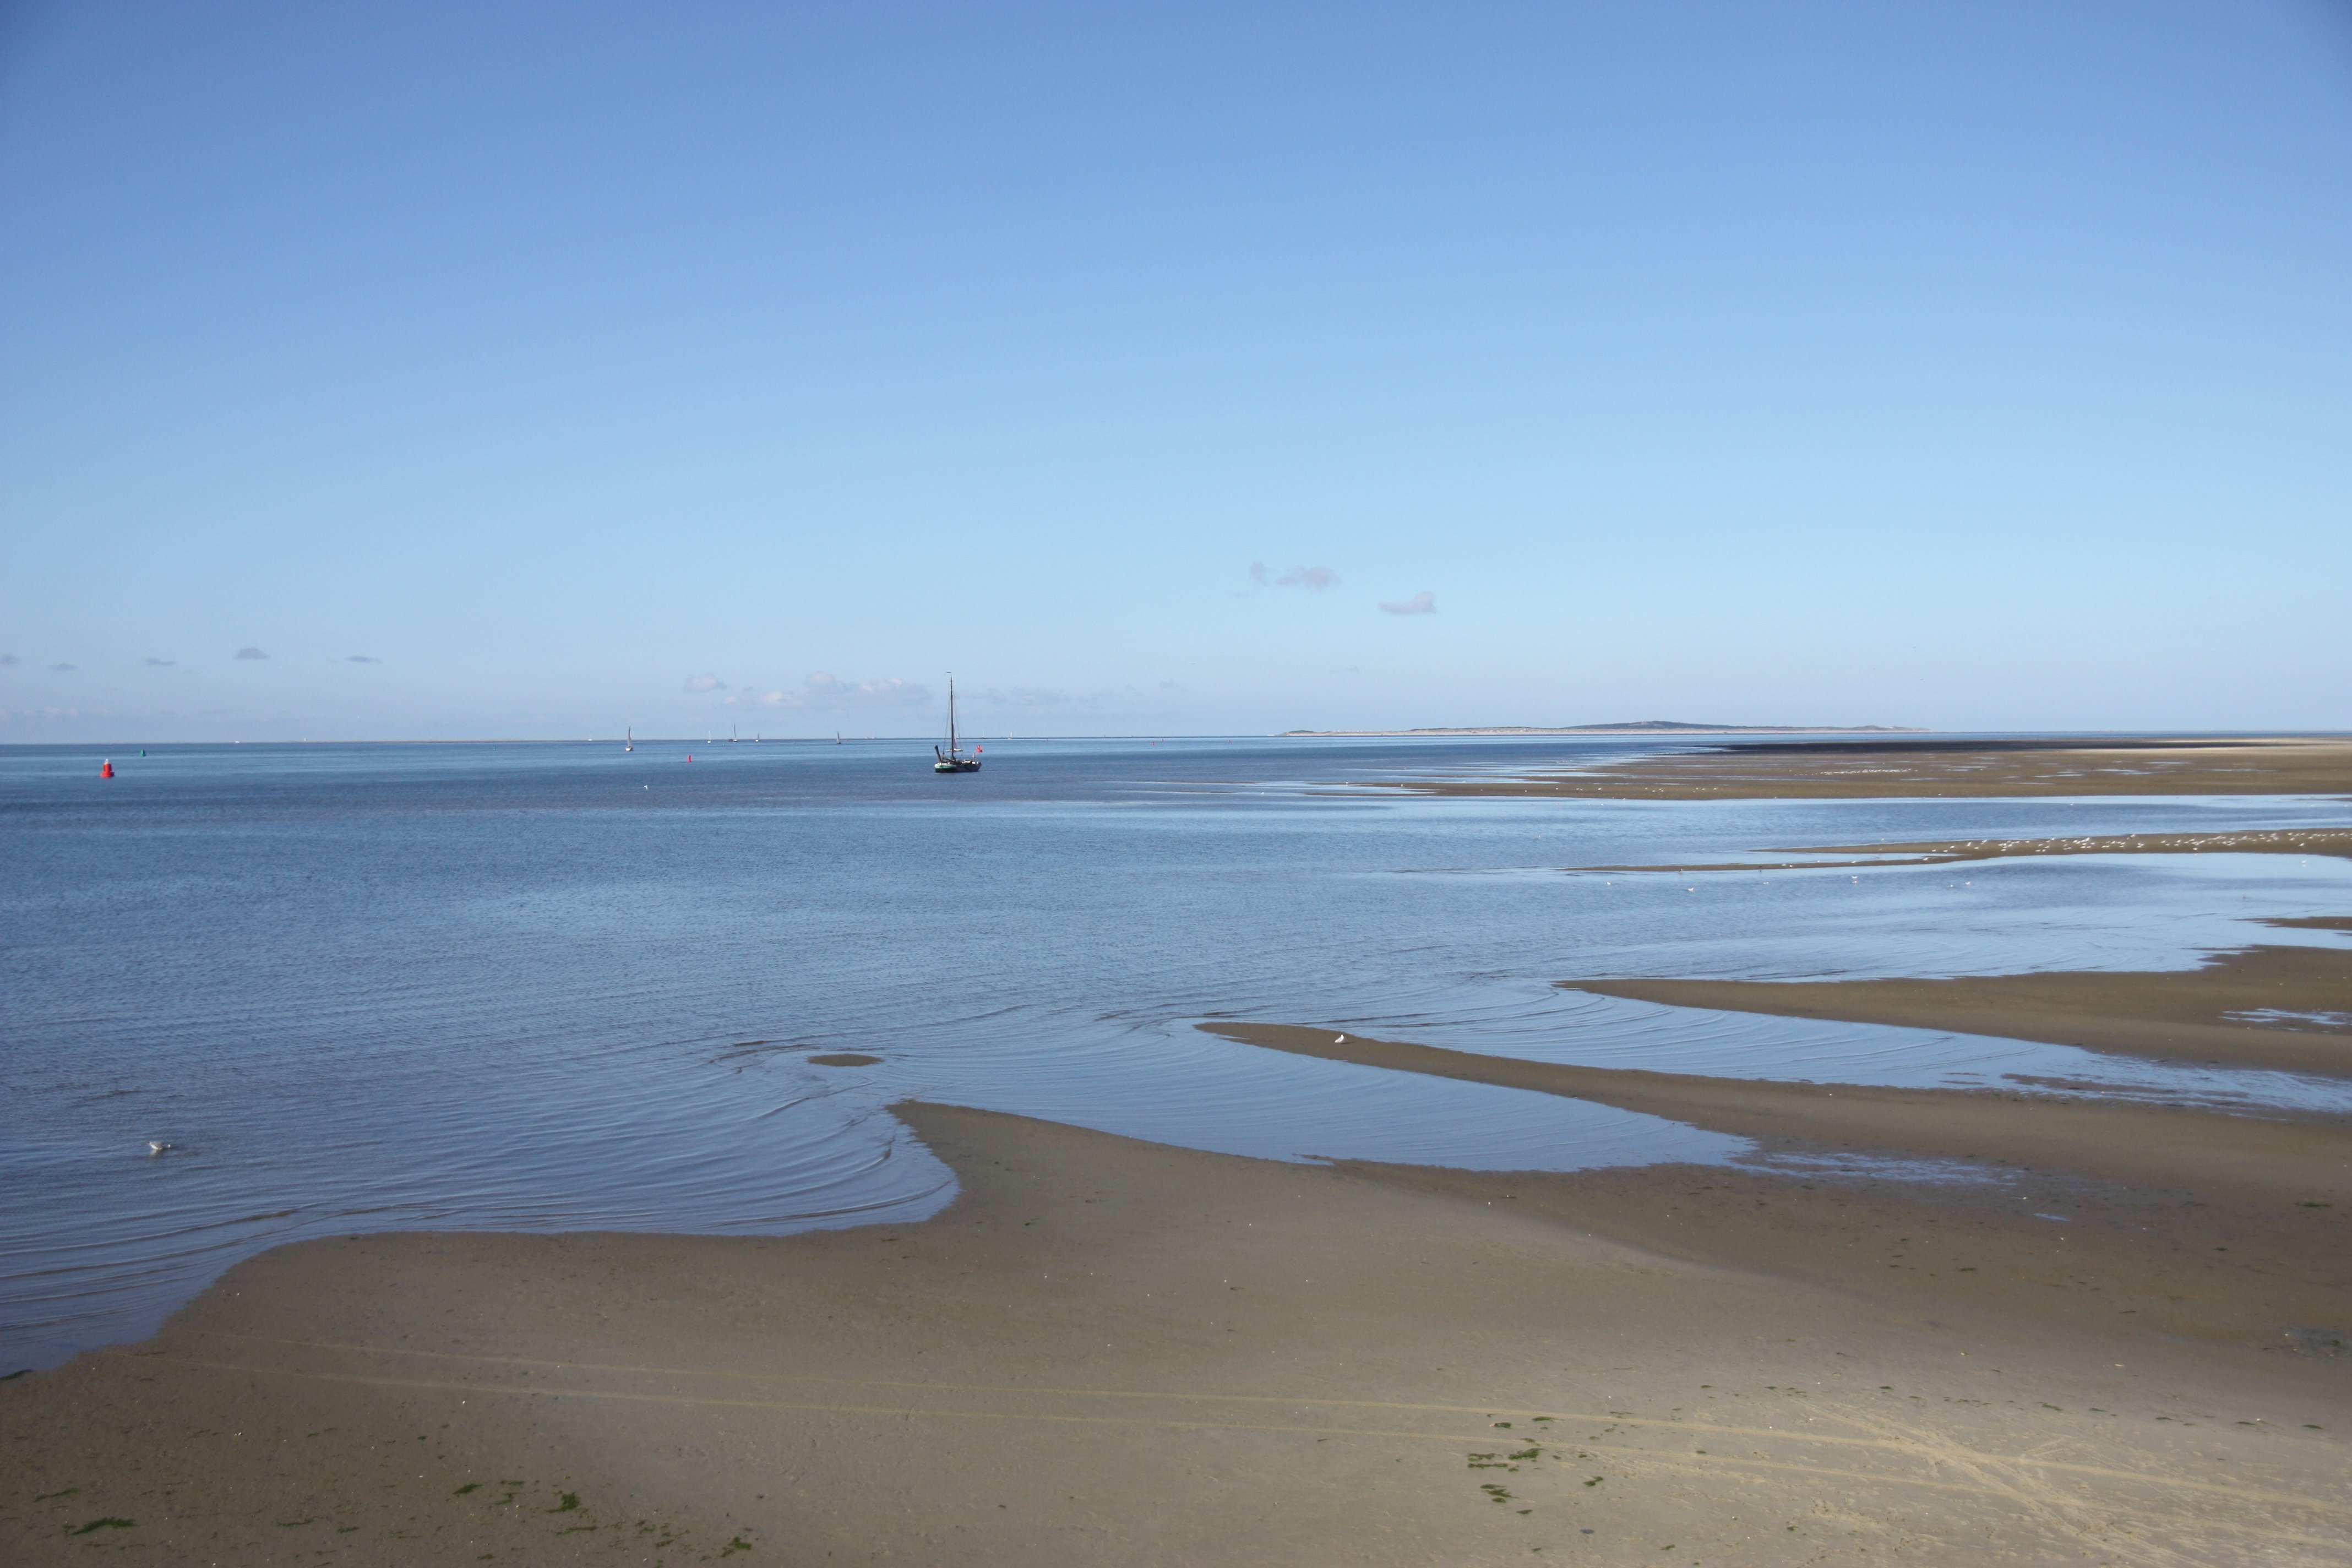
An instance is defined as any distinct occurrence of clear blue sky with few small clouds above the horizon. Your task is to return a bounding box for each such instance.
[0,0,2352,741]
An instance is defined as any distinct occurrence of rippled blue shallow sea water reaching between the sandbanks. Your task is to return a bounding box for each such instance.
[0,738,2352,1366]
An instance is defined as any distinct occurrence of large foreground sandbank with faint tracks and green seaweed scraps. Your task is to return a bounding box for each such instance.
[0,1105,2352,1566]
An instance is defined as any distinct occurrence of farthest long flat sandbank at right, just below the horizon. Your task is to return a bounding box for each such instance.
[1376,736,2352,799]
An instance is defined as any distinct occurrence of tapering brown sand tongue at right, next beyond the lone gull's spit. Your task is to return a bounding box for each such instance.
[1562,917,2352,1077]
